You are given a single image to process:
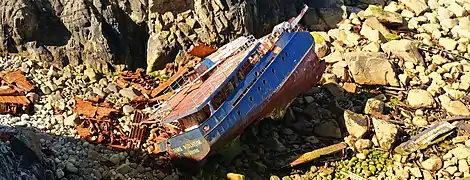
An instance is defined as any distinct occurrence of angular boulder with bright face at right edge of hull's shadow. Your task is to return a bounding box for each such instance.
[344,110,369,138]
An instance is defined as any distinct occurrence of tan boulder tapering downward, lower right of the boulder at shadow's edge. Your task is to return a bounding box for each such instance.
[372,118,398,150]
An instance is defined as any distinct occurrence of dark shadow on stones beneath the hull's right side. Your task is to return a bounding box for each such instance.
[196,83,398,179]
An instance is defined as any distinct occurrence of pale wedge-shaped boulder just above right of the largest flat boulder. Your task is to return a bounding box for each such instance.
[382,39,424,64]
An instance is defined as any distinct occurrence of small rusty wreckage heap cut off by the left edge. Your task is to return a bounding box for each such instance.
[0,71,35,115]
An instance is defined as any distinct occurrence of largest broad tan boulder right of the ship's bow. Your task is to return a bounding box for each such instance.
[344,52,399,86]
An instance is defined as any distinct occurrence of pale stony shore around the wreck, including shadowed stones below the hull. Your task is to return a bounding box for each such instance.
[0,0,470,180]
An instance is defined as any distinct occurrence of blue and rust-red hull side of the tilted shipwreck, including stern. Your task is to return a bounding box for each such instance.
[159,32,325,160]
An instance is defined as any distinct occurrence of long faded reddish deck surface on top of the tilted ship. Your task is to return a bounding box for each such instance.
[162,43,256,123]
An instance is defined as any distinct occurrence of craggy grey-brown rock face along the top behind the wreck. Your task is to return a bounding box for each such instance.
[0,0,344,73]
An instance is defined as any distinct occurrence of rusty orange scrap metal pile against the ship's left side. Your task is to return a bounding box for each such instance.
[73,51,206,153]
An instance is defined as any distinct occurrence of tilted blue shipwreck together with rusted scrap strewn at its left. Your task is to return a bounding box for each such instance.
[77,6,325,161]
